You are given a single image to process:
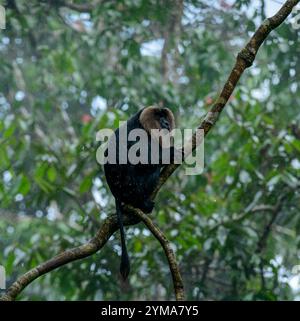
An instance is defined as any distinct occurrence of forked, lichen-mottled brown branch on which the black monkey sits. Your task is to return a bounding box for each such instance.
[0,0,300,300]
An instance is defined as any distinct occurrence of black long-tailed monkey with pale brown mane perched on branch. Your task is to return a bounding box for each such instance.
[104,106,181,280]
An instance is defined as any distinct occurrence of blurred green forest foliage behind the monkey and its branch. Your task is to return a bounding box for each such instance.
[0,0,300,300]
